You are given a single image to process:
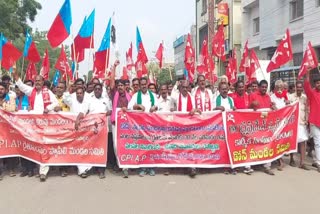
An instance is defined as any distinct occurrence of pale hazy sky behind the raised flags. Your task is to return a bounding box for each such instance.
[31,0,195,76]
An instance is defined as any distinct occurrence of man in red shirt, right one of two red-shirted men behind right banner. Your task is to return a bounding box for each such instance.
[249,80,275,175]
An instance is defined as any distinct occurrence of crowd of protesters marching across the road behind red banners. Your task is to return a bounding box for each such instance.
[0,61,320,182]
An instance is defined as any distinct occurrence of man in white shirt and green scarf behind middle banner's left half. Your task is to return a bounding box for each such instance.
[128,77,158,177]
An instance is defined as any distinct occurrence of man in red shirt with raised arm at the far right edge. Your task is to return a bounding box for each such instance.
[304,72,320,172]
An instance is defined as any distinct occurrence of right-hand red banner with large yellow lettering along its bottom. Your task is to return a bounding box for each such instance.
[226,103,299,167]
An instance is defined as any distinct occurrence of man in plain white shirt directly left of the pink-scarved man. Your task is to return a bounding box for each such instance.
[89,83,112,179]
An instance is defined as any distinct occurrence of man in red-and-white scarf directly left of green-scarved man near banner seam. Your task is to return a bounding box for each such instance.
[192,75,213,112]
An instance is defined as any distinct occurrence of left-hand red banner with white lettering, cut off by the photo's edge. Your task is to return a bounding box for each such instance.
[0,110,108,166]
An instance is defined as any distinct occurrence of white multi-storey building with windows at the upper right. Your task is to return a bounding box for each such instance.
[241,0,320,82]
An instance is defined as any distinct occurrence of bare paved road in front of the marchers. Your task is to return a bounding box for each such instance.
[0,158,320,214]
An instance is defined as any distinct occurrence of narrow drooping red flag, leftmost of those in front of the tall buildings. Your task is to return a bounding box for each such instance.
[184,34,195,82]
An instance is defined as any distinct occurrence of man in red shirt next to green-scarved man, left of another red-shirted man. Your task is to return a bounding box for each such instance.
[229,80,249,109]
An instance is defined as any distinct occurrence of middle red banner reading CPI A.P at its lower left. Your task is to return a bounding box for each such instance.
[115,111,230,168]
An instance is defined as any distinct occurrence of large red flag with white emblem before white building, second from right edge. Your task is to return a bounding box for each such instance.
[267,29,293,72]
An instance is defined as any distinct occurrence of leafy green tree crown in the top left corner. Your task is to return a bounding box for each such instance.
[0,0,42,38]
